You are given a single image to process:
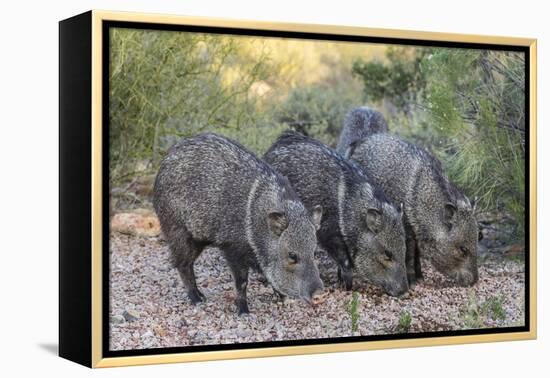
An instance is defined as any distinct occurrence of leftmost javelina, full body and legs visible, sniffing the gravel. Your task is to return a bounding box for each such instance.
[154,134,323,314]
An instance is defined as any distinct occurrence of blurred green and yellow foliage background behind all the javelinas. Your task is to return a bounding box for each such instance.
[109,29,525,237]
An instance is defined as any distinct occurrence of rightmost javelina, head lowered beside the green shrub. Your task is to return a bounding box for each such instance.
[347,134,478,286]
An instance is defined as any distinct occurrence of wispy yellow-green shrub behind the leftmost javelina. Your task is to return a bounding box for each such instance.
[109,28,273,186]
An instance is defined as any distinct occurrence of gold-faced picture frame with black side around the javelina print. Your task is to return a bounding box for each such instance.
[60,10,537,368]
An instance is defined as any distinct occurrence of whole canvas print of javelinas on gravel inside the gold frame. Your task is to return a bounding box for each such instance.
[105,27,528,351]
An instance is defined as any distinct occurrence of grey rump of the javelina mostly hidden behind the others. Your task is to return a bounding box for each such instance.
[336,106,388,155]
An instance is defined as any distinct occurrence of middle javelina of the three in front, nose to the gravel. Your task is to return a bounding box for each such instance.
[264,132,408,295]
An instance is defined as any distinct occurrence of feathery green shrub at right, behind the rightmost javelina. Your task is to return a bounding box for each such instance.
[423,49,525,238]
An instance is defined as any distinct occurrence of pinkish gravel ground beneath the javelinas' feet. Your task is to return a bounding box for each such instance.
[110,232,525,350]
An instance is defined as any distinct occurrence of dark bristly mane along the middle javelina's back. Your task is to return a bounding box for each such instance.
[266,130,391,207]
